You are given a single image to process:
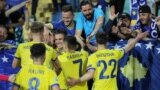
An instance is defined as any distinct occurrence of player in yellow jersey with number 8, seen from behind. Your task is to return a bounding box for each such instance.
[12,43,60,90]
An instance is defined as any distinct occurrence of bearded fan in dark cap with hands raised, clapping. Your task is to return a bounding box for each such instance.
[105,12,131,41]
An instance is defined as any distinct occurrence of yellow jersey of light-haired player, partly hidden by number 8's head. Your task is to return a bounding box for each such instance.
[15,42,56,68]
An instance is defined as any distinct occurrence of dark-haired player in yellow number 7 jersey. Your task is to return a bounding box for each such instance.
[58,36,88,90]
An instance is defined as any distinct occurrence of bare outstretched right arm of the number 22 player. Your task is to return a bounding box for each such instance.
[124,32,147,53]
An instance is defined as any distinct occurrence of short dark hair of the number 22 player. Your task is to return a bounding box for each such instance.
[96,32,108,44]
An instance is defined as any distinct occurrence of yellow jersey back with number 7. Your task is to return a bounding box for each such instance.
[58,51,88,90]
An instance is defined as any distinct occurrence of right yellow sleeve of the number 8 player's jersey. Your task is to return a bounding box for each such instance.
[49,70,59,87]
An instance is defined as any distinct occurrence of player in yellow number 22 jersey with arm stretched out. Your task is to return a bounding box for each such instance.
[67,33,148,90]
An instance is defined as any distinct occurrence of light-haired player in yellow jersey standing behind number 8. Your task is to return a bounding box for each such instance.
[12,22,56,68]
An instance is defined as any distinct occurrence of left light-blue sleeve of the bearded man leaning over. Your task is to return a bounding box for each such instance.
[76,13,84,31]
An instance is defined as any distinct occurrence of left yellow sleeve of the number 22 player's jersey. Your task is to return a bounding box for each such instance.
[87,55,96,70]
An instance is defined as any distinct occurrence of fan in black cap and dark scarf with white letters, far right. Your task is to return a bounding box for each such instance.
[133,5,160,39]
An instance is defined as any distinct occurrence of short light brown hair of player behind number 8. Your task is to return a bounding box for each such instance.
[31,22,44,33]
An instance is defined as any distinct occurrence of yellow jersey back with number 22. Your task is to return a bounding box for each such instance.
[87,49,124,90]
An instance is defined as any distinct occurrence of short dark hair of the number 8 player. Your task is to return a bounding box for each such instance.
[30,43,46,58]
